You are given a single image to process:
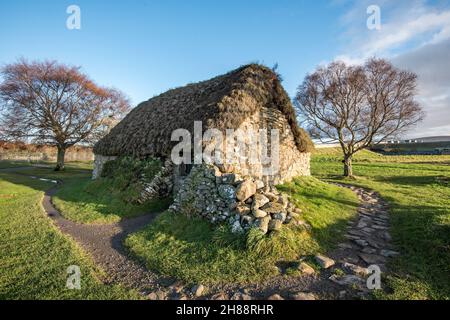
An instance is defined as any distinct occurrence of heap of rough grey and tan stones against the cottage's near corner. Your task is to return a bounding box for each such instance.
[170,164,309,234]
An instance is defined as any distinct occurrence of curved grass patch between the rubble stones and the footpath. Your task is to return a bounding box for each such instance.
[126,178,358,284]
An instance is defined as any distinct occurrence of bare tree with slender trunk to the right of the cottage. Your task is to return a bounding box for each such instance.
[294,58,423,176]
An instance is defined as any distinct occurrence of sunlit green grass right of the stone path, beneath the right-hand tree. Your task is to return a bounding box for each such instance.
[311,149,450,299]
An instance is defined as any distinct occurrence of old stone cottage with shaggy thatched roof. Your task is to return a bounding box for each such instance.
[93,64,312,232]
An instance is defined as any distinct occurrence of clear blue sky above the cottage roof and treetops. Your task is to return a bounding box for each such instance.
[0,0,450,135]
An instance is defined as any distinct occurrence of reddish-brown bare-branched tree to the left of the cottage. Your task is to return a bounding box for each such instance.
[0,59,129,170]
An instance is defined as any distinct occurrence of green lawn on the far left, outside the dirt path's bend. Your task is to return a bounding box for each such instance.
[0,172,138,300]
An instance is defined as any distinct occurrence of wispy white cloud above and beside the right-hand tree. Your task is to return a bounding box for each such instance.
[336,0,450,136]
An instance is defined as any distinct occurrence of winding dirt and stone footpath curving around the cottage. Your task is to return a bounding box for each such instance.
[1,168,399,300]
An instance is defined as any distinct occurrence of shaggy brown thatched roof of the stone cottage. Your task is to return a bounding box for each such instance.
[94,64,312,157]
